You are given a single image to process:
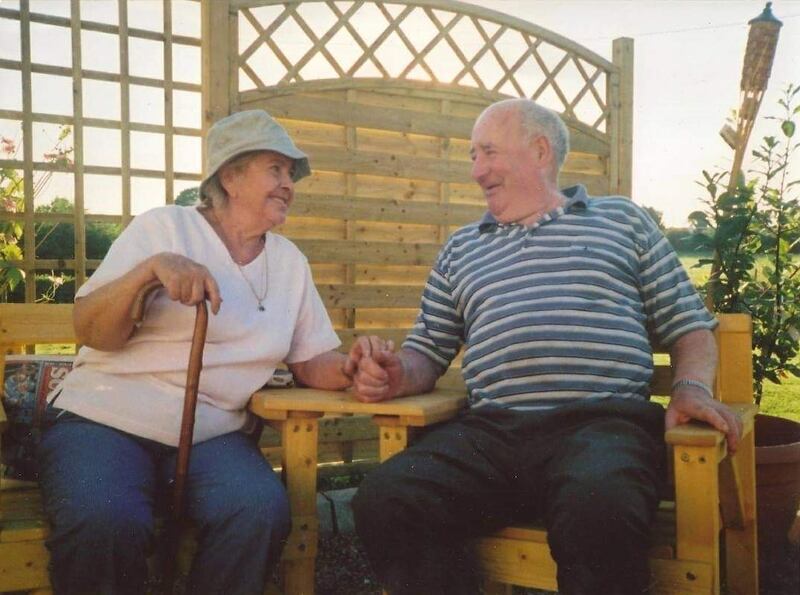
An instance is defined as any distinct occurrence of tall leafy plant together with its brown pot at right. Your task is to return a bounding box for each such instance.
[689,85,800,592]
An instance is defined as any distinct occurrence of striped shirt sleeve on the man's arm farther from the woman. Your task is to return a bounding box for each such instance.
[639,215,717,347]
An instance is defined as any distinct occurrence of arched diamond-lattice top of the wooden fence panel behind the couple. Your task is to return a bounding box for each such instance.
[232,0,615,132]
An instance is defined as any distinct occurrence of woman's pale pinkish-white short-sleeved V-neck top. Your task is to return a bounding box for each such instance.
[50,205,340,446]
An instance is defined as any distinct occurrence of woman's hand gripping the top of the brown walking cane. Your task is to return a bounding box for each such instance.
[149,252,222,314]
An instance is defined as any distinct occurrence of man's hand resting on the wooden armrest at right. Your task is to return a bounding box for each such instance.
[665,386,742,452]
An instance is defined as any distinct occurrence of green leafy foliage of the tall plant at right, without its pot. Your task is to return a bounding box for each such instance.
[689,84,800,403]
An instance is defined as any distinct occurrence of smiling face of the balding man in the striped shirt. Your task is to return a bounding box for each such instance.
[470,108,544,223]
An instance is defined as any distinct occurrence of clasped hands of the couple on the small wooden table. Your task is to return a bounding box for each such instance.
[343,336,404,403]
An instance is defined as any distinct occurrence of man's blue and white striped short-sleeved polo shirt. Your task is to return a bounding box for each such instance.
[404,186,716,409]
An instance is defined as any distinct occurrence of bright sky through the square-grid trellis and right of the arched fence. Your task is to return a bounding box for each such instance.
[0,0,800,227]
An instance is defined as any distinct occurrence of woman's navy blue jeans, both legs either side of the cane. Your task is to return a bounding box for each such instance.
[39,413,290,595]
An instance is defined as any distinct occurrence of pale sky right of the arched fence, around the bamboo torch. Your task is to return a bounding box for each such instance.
[468,0,800,227]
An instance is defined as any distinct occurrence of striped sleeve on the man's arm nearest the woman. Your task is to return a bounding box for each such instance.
[403,256,464,368]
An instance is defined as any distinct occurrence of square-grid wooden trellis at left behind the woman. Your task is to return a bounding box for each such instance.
[0,0,203,301]
